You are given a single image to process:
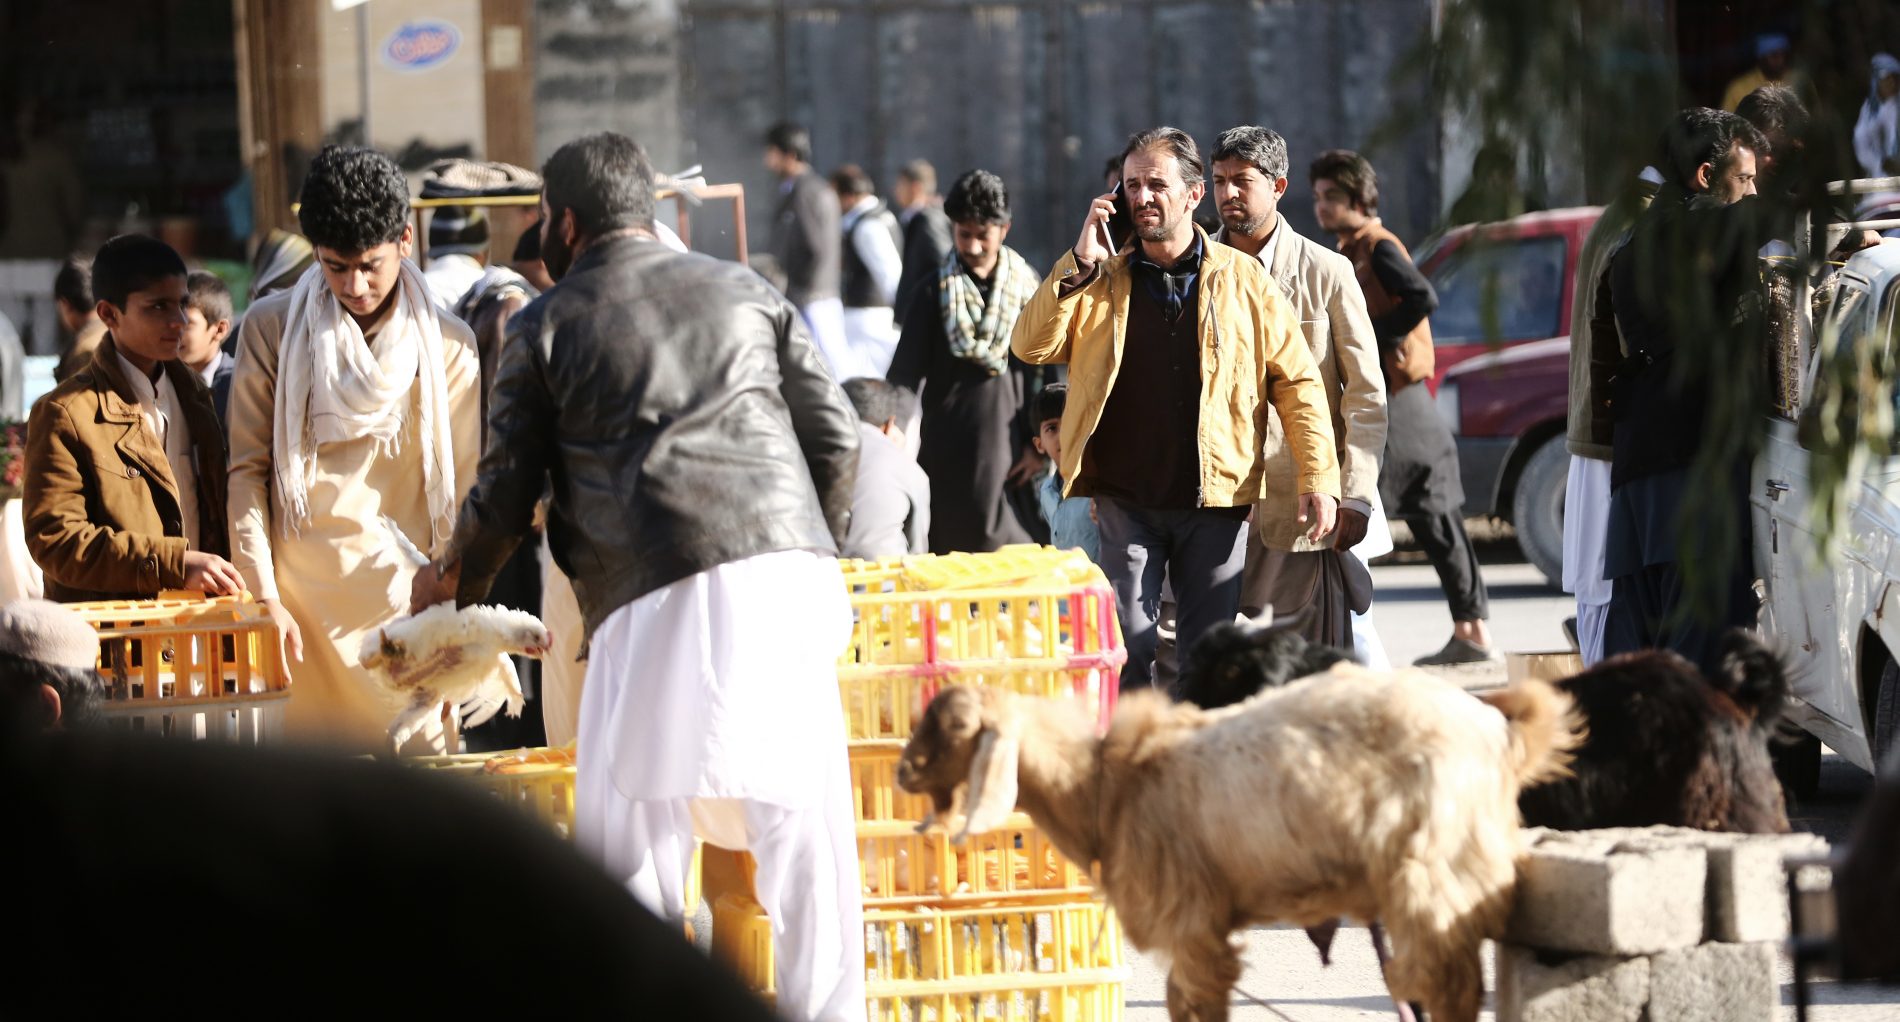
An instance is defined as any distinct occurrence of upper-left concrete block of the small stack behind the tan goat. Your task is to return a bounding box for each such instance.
[1505,840,1708,956]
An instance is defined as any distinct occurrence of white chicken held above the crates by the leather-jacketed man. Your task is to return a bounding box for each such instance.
[357,517,553,750]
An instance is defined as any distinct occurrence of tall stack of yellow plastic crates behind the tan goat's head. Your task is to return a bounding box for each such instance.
[713,547,1125,1022]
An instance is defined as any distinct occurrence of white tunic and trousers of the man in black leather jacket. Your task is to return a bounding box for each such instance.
[576,551,865,1022]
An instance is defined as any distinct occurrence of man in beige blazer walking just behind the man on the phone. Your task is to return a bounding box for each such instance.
[1214,125,1385,650]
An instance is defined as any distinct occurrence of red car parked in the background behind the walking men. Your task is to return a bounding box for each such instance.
[1419,205,1602,585]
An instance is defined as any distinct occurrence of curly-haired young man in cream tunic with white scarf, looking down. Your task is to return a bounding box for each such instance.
[230,146,481,747]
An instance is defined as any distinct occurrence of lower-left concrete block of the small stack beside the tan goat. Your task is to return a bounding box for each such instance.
[1497,942,1663,1022]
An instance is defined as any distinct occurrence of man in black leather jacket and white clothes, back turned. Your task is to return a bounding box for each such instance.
[414,133,865,1020]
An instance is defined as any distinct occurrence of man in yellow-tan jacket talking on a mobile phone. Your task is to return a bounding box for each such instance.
[1011,127,1340,690]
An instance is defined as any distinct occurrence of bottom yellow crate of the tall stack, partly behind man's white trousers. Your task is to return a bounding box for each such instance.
[713,895,1125,1022]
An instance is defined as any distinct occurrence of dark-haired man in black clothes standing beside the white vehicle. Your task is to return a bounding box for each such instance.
[1604,108,1784,671]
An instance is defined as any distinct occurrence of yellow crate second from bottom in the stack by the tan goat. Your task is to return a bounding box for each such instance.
[857,813,1091,908]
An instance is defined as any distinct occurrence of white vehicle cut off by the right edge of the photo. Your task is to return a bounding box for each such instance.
[1750,239,1900,771]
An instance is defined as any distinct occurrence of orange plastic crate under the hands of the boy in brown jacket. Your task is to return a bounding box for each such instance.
[68,593,291,745]
